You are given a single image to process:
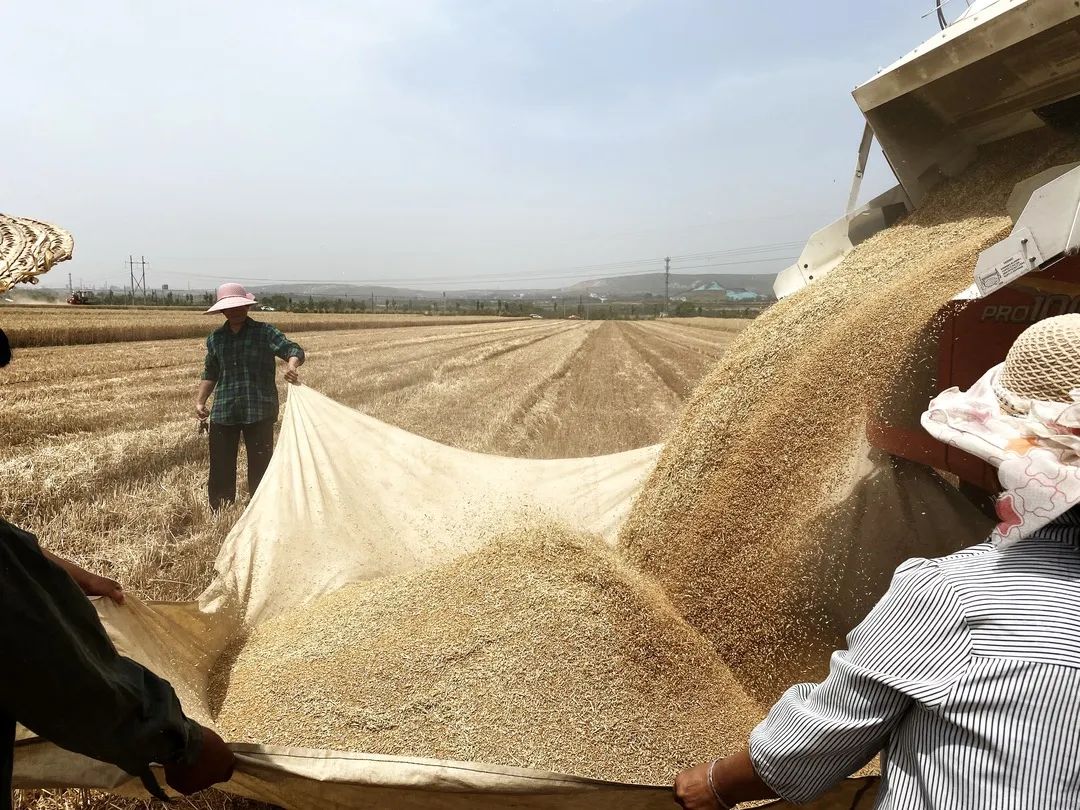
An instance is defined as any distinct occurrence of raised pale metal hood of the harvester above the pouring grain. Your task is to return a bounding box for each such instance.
[853,0,1080,206]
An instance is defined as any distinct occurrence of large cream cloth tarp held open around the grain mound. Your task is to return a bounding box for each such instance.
[15,387,894,810]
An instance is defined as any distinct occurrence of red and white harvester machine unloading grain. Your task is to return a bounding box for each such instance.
[773,0,1080,501]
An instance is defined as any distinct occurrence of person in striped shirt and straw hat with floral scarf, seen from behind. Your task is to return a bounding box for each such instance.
[675,314,1080,810]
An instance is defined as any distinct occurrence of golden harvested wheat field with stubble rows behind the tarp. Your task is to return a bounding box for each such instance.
[0,310,747,810]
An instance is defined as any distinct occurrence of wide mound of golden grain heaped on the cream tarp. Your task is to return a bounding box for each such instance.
[216,528,760,784]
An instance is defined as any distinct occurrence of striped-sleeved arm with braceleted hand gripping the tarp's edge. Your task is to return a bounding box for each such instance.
[676,561,971,808]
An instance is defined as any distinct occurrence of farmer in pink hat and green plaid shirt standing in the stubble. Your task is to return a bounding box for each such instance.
[195,284,305,510]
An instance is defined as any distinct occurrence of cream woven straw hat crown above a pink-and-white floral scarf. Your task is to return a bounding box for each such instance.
[994,314,1080,414]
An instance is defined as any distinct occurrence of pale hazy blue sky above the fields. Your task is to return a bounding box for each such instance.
[0,0,962,291]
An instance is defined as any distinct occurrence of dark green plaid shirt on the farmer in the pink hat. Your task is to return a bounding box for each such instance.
[202,318,303,424]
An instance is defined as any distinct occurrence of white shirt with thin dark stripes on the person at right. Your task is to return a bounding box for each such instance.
[750,510,1080,810]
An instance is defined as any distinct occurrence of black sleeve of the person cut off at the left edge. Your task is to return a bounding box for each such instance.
[0,521,202,777]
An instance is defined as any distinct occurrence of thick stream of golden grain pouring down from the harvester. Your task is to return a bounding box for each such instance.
[621,130,1080,701]
